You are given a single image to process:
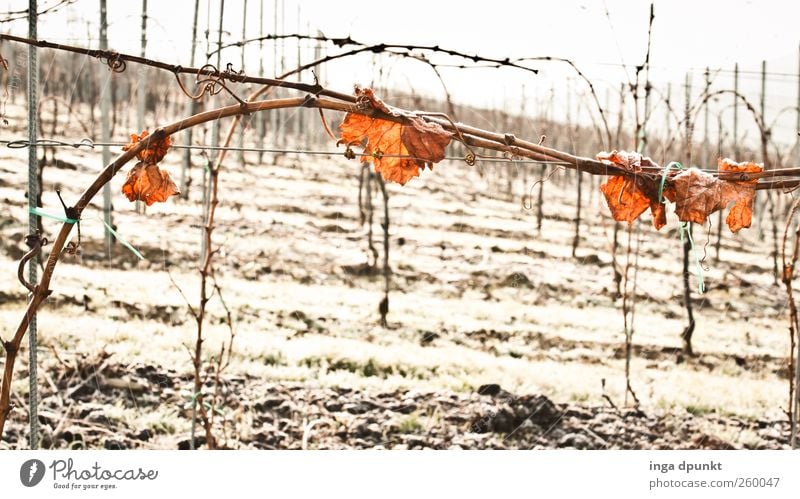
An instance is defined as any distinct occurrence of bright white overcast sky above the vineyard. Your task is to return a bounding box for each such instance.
[0,0,800,146]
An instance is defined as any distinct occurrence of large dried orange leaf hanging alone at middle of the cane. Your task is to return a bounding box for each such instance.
[339,87,453,185]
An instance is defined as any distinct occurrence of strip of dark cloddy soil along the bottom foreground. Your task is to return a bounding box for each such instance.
[0,366,789,449]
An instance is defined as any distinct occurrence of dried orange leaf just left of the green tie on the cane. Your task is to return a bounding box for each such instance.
[597,151,673,229]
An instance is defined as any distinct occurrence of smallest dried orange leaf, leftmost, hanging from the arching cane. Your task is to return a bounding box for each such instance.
[122,130,180,206]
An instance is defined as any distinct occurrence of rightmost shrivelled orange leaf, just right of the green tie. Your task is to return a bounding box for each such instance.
[672,159,763,232]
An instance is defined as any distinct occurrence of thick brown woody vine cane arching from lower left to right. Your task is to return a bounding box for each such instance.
[0,50,800,442]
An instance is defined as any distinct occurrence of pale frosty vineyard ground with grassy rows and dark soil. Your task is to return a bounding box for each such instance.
[0,101,789,448]
